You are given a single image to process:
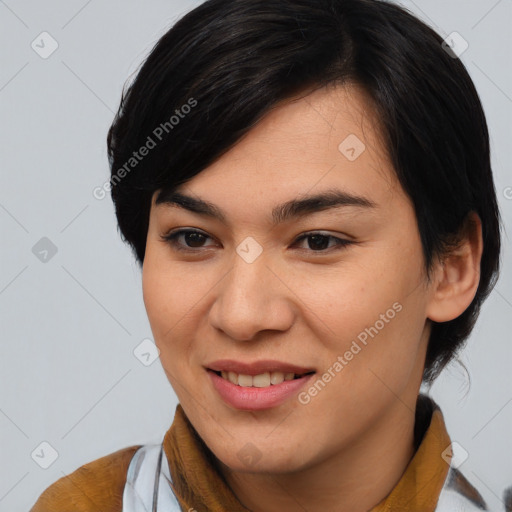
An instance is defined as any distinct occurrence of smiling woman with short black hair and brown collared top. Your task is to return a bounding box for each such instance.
[32,0,500,512]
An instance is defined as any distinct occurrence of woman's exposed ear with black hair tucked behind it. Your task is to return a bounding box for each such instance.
[427,212,483,322]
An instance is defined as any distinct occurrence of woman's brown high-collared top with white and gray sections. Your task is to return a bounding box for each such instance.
[31,395,487,512]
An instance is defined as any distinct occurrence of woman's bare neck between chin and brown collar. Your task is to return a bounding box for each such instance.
[218,400,416,512]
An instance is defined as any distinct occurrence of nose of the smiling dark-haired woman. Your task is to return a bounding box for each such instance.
[210,254,297,341]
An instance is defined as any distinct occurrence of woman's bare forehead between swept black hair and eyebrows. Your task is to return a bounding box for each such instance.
[154,85,401,217]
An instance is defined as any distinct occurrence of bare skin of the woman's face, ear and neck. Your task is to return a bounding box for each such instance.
[142,85,482,512]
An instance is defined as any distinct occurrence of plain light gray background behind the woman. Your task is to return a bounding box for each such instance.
[0,0,512,512]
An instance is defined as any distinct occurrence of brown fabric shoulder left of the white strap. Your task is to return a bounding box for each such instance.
[30,446,140,512]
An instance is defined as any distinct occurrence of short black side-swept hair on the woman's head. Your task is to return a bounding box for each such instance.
[107,0,501,382]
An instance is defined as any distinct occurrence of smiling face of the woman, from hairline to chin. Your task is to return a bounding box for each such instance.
[142,86,431,473]
